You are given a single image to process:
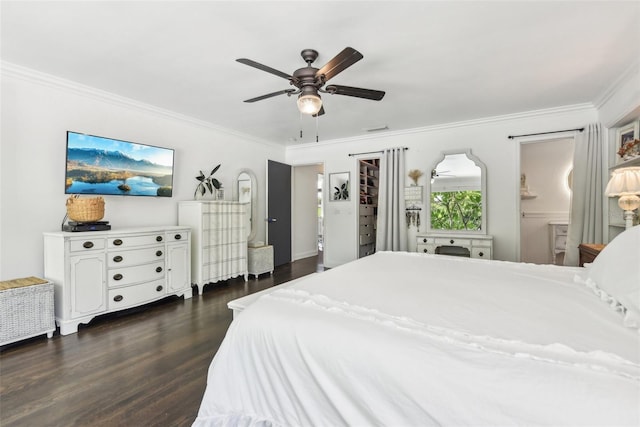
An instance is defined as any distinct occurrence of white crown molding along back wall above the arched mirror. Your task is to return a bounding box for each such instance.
[287,102,595,150]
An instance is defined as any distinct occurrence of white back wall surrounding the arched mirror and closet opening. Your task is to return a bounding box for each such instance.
[286,105,597,267]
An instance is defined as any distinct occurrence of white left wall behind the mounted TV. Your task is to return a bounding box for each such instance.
[0,64,284,280]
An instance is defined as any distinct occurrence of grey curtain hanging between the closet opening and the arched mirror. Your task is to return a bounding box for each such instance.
[376,148,407,251]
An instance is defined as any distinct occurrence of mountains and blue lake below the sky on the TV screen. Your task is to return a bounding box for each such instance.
[66,148,173,197]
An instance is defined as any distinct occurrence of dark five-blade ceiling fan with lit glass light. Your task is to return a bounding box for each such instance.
[236,47,385,116]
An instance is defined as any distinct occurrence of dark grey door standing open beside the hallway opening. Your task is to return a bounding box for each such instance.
[267,160,291,266]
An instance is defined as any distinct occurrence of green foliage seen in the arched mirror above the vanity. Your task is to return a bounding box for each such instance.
[431,191,482,231]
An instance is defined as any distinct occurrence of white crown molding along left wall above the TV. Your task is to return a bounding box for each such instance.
[0,61,283,149]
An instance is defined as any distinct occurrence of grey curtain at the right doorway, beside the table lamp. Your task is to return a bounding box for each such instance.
[564,123,607,266]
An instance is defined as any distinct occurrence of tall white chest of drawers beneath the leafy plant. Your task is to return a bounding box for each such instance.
[178,200,248,295]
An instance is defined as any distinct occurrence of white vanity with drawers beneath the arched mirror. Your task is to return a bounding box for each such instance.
[416,233,493,259]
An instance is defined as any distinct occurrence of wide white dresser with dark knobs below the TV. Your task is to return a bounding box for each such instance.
[44,226,192,335]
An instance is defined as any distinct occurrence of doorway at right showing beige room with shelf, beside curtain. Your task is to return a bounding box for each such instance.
[520,137,574,265]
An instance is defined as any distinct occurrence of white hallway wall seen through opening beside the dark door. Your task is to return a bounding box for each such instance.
[291,165,322,261]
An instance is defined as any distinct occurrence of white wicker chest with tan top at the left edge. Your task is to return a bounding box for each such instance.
[0,277,56,345]
